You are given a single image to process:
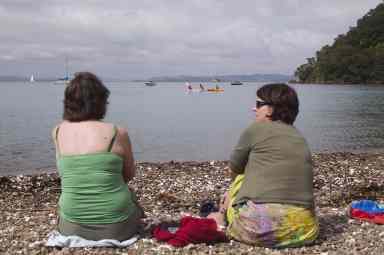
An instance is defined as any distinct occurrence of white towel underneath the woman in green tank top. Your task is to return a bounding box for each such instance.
[45,230,139,248]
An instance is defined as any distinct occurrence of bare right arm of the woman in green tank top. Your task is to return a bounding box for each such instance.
[119,129,136,182]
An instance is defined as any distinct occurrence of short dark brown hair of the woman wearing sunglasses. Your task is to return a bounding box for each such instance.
[256,83,299,125]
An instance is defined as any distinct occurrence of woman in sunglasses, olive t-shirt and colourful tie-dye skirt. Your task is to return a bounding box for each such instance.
[208,84,319,248]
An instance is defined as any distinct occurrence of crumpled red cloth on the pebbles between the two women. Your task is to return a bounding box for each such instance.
[153,216,227,247]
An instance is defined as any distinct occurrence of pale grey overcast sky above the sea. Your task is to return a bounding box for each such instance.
[0,0,383,79]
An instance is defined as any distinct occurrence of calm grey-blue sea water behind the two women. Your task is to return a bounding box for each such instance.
[0,82,384,175]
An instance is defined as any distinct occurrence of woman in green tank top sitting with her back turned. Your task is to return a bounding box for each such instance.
[52,72,143,241]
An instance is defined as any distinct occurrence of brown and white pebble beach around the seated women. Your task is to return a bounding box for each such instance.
[0,152,384,255]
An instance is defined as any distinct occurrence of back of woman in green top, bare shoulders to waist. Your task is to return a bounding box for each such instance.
[56,121,135,224]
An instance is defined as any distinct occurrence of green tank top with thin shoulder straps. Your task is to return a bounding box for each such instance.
[56,128,137,224]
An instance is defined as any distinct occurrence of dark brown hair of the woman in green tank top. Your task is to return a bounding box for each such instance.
[63,72,109,122]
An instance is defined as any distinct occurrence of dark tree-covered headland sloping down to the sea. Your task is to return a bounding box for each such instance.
[295,3,384,84]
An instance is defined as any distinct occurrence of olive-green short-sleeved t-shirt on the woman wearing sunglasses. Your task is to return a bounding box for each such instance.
[230,121,313,208]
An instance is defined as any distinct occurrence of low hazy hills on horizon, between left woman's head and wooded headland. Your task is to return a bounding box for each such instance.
[136,74,293,82]
